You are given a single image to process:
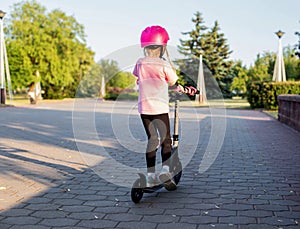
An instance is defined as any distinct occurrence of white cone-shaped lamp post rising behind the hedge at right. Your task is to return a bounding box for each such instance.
[273,30,286,82]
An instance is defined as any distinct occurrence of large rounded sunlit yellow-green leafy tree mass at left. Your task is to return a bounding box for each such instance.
[6,1,94,98]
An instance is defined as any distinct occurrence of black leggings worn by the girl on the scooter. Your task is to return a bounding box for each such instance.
[141,113,172,173]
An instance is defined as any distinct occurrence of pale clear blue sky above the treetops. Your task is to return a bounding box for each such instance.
[0,0,300,66]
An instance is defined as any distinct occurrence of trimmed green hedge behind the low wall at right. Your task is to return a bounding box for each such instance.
[247,81,300,110]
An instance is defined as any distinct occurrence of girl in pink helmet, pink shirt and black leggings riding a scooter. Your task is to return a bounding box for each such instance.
[133,26,197,191]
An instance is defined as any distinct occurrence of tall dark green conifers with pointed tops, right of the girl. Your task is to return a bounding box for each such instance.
[178,12,233,96]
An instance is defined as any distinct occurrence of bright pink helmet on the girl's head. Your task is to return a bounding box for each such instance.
[141,25,169,48]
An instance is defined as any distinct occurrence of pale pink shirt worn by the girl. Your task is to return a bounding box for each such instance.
[133,57,178,115]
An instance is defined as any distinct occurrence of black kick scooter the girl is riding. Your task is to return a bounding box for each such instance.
[131,96,182,203]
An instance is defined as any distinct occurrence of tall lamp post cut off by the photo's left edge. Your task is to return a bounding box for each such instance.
[0,10,5,104]
